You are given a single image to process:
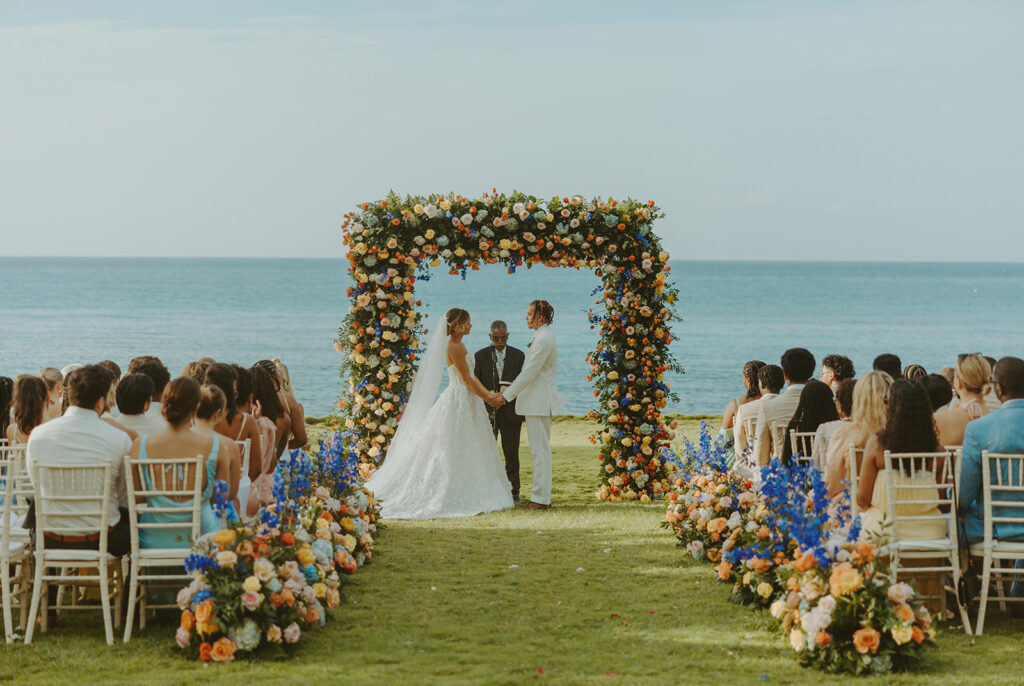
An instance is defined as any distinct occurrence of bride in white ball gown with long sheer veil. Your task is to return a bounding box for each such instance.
[367,308,512,519]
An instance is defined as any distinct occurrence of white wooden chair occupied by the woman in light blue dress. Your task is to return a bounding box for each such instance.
[124,455,205,643]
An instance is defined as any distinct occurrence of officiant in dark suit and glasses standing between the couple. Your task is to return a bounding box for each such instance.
[473,320,526,503]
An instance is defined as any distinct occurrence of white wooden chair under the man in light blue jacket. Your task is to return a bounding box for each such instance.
[968,451,1024,636]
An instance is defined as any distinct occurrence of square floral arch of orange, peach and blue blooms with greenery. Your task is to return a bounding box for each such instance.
[335,190,682,500]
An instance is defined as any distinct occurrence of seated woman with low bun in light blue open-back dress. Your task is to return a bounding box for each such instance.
[131,377,231,536]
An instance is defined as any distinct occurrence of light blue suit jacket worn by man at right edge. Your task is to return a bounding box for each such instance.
[958,398,1024,543]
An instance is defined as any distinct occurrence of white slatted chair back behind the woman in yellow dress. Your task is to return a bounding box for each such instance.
[885,451,956,541]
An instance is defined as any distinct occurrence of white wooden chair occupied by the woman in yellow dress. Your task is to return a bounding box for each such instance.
[885,451,971,635]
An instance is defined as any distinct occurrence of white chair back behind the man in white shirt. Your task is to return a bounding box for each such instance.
[32,462,114,552]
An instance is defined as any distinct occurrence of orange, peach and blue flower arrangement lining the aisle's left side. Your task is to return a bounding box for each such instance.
[175,434,380,662]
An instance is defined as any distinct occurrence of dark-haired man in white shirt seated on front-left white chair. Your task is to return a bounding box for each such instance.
[25,365,131,555]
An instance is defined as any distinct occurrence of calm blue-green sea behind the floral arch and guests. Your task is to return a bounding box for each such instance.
[0,258,1024,415]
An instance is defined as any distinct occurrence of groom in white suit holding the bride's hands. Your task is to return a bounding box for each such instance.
[492,300,565,510]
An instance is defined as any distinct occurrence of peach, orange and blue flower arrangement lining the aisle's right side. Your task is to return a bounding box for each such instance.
[663,425,935,674]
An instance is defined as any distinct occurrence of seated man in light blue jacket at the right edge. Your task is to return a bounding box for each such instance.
[957,357,1024,548]
